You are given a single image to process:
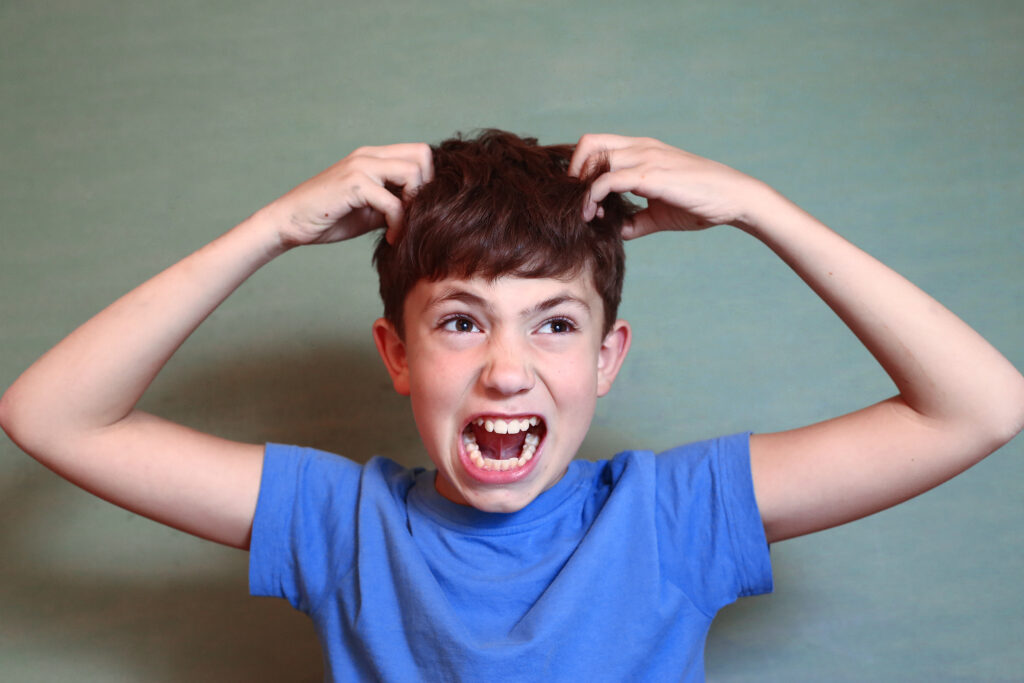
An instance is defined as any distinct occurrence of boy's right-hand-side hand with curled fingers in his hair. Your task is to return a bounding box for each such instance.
[569,134,767,240]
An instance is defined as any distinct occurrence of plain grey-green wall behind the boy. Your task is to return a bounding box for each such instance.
[0,0,1024,681]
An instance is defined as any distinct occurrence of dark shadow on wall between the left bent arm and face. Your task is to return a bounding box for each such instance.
[141,337,429,466]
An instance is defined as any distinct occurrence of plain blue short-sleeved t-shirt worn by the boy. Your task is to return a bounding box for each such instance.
[250,434,771,681]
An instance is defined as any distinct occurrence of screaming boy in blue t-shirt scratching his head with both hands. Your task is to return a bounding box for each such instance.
[0,131,1024,680]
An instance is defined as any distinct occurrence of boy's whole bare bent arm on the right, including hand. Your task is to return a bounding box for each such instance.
[569,135,1024,542]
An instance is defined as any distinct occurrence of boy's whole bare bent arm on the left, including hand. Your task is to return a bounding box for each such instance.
[0,144,432,548]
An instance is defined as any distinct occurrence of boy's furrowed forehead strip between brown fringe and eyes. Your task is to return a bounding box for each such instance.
[404,268,602,321]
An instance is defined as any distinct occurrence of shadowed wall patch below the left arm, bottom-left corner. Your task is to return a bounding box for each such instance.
[0,468,323,683]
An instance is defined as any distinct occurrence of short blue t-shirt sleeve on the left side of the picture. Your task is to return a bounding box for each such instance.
[249,443,362,612]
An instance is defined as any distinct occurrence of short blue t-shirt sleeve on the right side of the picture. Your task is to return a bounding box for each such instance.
[655,433,772,616]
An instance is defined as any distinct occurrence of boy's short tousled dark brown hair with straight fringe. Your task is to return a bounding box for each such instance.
[374,129,637,336]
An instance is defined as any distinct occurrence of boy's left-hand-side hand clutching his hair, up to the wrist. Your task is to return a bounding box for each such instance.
[266,143,433,247]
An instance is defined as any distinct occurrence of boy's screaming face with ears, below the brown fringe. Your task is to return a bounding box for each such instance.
[374,273,630,512]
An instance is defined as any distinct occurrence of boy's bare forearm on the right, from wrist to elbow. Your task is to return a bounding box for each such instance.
[739,188,1024,447]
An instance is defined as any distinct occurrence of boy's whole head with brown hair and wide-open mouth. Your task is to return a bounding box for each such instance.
[374,130,635,512]
